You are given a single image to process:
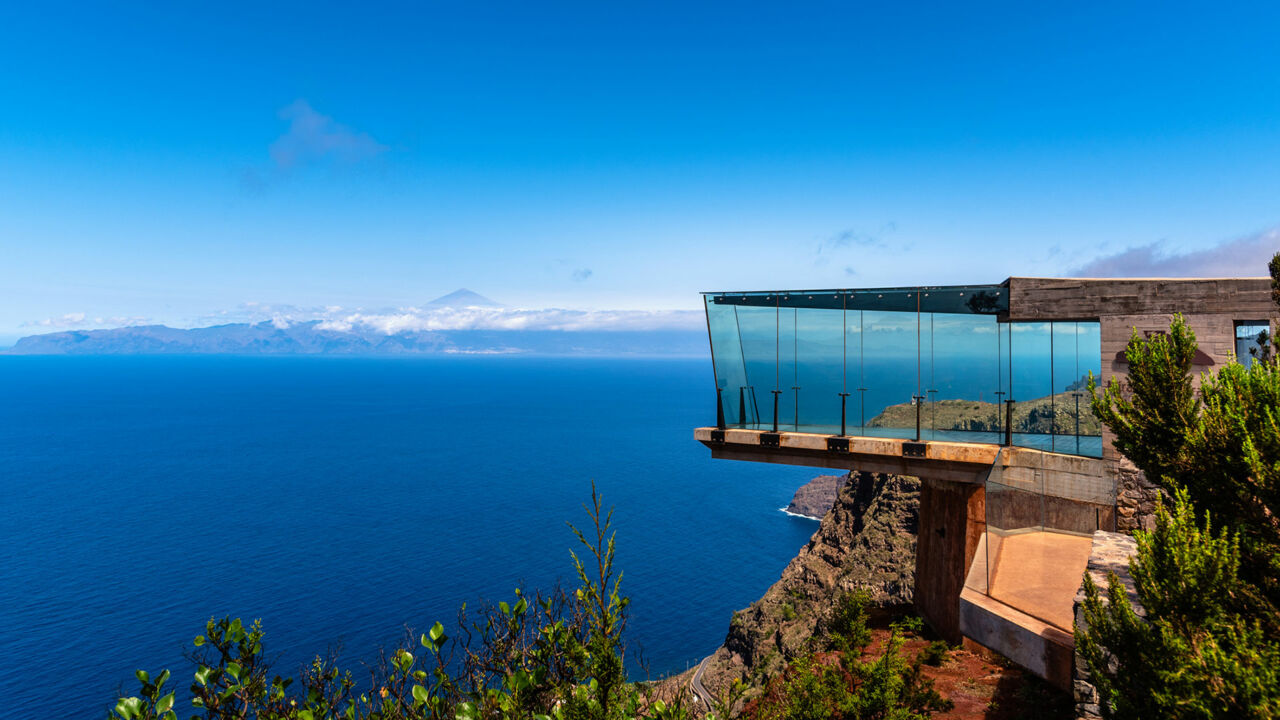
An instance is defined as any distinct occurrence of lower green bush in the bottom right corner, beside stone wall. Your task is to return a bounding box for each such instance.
[1075,491,1280,719]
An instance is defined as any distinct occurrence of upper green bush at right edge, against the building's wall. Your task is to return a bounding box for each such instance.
[1089,315,1280,617]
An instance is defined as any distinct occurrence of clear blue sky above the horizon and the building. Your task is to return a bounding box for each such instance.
[0,3,1280,345]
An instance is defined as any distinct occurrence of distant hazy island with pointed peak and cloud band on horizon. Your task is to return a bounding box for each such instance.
[3,288,707,356]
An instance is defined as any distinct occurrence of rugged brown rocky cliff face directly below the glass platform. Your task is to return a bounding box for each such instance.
[703,473,920,692]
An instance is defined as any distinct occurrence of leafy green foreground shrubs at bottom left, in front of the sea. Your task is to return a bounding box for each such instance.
[109,487,689,720]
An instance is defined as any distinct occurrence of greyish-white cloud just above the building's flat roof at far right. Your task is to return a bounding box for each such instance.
[1071,228,1280,278]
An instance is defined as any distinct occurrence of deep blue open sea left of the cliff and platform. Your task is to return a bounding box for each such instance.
[0,356,817,719]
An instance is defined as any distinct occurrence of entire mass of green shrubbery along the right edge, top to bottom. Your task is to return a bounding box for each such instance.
[1075,294,1280,719]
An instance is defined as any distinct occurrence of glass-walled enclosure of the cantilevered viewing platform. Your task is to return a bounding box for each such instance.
[703,284,1102,457]
